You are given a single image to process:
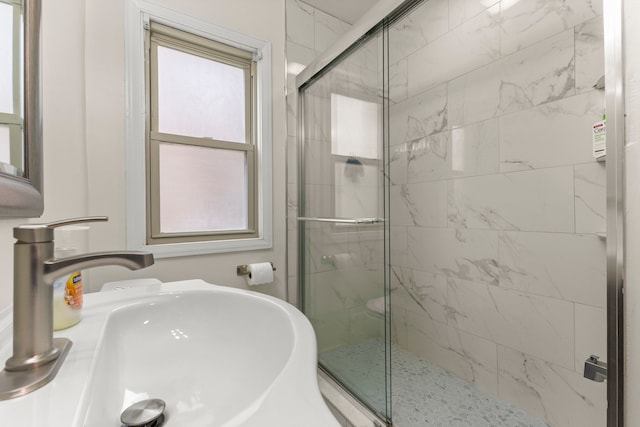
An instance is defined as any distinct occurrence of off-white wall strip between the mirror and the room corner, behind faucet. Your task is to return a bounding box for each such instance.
[0,0,88,309]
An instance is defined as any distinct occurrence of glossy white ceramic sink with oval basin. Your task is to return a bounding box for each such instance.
[0,281,338,427]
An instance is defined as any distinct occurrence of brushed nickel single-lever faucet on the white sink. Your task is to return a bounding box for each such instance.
[0,217,154,400]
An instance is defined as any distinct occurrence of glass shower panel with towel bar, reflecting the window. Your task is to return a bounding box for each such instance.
[298,29,391,418]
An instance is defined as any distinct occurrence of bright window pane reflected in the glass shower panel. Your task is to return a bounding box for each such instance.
[331,93,381,159]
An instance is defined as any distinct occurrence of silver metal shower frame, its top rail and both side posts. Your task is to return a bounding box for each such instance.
[296,0,625,427]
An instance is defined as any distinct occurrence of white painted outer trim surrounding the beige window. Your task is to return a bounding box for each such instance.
[125,0,273,258]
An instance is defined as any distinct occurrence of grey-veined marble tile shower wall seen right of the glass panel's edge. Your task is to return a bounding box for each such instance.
[389,0,606,427]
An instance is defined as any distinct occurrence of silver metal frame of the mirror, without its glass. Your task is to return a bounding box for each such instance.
[0,0,44,218]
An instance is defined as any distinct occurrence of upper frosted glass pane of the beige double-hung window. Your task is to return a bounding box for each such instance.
[158,46,245,142]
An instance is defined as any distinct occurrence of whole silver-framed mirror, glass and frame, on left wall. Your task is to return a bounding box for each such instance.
[0,0,44,218]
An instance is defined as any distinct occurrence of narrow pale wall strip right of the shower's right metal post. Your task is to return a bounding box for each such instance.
[624,0,640,427]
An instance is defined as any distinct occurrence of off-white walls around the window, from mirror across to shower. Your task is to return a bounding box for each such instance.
[0,0,286,309]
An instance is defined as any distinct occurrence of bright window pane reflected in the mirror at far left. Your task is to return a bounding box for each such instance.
[0,3,13,114]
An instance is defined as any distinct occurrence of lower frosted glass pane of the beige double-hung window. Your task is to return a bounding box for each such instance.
[160,143,248,233]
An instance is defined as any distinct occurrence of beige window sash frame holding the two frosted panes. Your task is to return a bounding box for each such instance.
[146,22,259,245]
